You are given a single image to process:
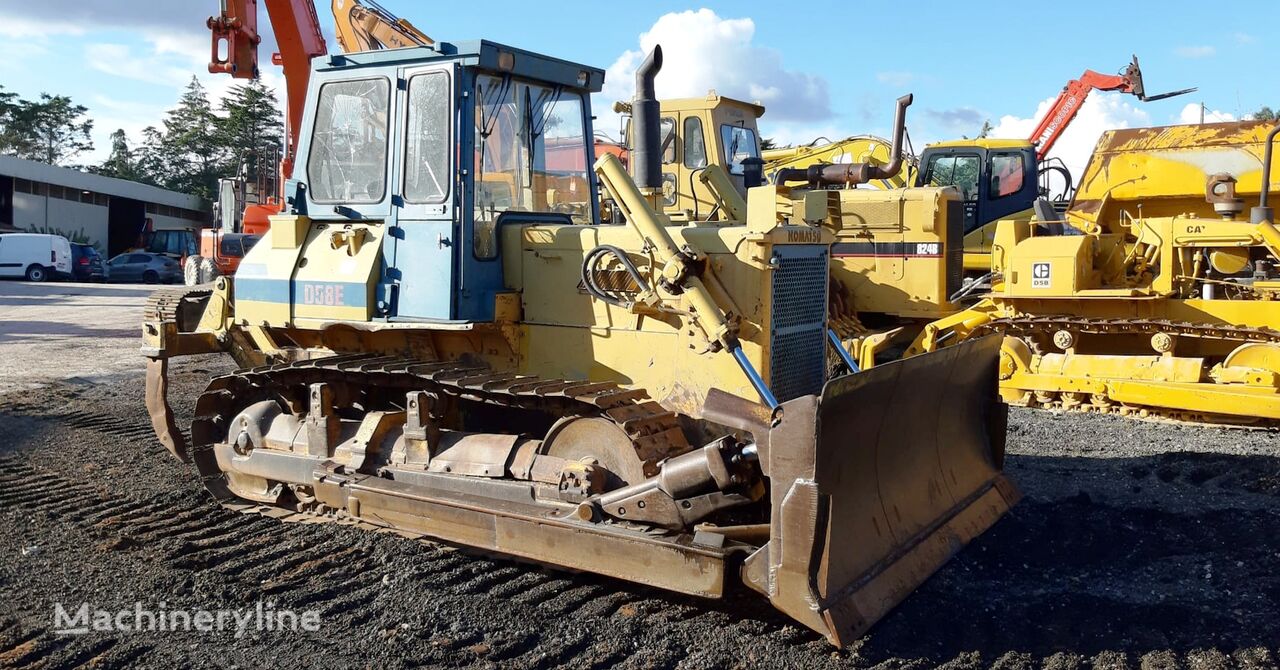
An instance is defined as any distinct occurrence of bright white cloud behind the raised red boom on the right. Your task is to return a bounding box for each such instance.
[991,92,1151,179]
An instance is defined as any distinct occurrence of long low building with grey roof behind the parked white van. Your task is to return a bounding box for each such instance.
[0,156,209,256]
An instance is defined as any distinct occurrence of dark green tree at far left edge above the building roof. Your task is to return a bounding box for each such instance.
[0,94,93,165]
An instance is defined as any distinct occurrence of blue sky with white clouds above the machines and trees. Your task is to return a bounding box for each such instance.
[0,0,1280,178]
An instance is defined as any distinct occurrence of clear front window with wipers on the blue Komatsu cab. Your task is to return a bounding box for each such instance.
[474,74,594,259]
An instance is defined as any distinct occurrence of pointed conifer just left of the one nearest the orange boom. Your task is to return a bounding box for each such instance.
[159,76,230,200]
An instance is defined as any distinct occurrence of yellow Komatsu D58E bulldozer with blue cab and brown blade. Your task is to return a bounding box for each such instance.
[143,41,1018,643]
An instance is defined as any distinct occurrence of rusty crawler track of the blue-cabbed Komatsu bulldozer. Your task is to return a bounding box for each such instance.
[191,354,690,521]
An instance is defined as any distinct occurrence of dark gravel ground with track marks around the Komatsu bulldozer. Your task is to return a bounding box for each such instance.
[0,360,1280,669]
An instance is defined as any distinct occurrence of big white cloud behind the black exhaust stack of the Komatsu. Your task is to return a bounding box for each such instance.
[598,9,831,128]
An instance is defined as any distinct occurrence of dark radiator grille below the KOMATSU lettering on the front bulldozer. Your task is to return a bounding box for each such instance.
[769,245,829,402]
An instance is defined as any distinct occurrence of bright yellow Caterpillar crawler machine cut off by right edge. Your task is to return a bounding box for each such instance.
[911,122,1280,425]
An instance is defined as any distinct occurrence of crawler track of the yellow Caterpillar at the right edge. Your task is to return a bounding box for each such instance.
[968,315,1280,429]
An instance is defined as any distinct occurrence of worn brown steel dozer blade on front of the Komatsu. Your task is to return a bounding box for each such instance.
[742,337,1019,646]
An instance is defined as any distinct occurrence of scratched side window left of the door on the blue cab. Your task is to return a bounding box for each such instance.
[307,76,392,205]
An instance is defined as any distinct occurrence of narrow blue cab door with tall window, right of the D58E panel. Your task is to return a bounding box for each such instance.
[387,65,461,319]
